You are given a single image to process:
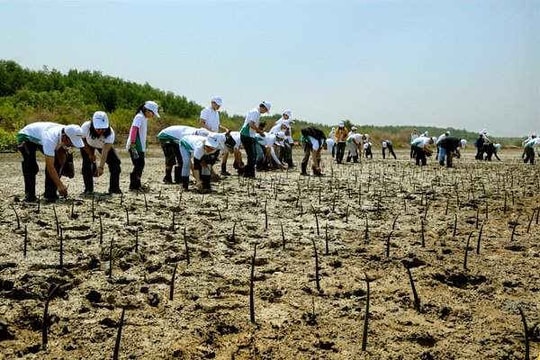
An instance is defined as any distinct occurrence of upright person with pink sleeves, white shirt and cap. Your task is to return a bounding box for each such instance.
[126,101,160,191]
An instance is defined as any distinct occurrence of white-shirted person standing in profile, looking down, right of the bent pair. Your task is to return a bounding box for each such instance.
[240,101,272,178]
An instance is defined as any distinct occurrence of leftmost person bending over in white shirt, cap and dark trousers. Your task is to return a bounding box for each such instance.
[17,122,84,202]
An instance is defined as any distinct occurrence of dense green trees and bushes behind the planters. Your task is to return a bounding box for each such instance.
[0,60,520,150]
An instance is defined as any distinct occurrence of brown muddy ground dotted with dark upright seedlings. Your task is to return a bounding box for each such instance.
[0,150,540,360]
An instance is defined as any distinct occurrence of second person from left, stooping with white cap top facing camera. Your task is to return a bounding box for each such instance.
[81,111,122,195]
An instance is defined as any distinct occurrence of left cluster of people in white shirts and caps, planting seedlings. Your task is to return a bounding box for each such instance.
[17,96,300,202]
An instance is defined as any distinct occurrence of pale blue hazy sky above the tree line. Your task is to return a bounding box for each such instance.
[0,0,540,136]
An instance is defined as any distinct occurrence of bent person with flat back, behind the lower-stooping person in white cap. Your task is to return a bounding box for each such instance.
[157,125,210,184]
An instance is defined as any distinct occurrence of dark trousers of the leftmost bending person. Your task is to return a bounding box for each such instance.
[18,141,63,201]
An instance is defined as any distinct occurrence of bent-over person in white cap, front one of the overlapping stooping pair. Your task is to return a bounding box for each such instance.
[180,135,219,193]
